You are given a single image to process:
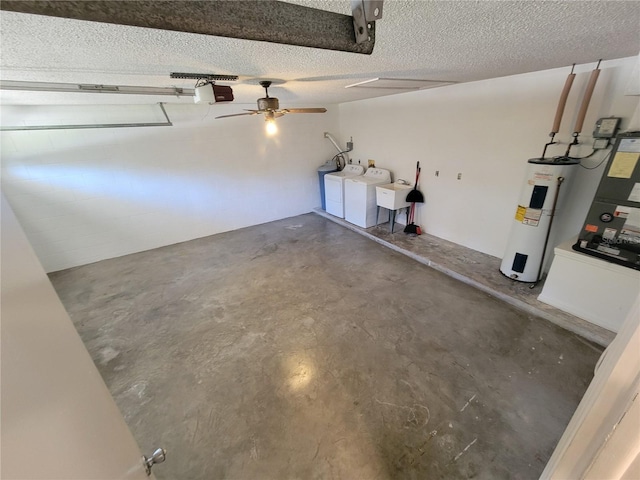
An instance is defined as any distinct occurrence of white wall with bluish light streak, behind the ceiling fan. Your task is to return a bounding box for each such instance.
[1,104,338,272]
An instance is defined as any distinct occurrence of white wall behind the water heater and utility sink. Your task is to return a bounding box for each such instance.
[340,57,638,257]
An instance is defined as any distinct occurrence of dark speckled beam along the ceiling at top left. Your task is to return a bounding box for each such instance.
[0,0,375,55]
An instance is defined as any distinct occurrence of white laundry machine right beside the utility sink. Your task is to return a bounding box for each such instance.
[344,168,391,228]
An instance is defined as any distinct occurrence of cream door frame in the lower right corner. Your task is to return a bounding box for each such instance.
[540,291,640,480]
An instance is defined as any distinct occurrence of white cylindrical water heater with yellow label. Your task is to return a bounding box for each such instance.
[500,157,579,282]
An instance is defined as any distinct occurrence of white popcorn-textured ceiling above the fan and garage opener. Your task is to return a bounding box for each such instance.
[0,0,640,107]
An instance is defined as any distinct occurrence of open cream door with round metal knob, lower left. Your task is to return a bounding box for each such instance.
[0,195,161,480]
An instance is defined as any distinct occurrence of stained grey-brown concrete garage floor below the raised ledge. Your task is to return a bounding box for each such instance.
[51,214,601,480]
